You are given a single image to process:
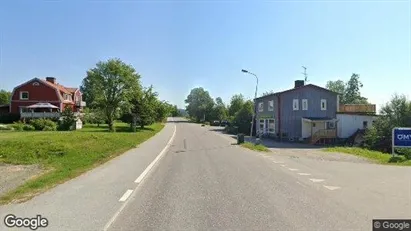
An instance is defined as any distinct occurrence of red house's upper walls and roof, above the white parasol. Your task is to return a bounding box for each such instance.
[10,77,82,114]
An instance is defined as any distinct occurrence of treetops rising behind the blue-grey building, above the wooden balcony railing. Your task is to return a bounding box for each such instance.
[325,73,368,104]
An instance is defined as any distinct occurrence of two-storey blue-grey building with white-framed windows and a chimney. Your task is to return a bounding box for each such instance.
[256,80,339,143]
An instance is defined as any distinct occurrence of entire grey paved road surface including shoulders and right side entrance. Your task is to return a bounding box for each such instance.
[0,119,411,231]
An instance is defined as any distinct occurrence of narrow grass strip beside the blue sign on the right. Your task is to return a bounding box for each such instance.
[324,147,411,166]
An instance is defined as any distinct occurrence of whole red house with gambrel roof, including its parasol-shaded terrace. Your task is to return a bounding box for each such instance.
[10,77,85,118]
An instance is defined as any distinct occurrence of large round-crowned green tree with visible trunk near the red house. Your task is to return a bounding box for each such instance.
[81,59,141,131]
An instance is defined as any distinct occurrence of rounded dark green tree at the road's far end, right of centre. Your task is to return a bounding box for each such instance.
[185,87,214,122]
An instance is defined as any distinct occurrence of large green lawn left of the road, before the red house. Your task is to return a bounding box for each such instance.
[0,123,164,204]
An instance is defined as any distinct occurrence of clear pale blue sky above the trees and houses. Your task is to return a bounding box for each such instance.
[0,0,411,108]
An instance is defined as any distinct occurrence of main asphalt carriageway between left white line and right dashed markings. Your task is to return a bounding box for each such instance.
[109,119,390,230]
